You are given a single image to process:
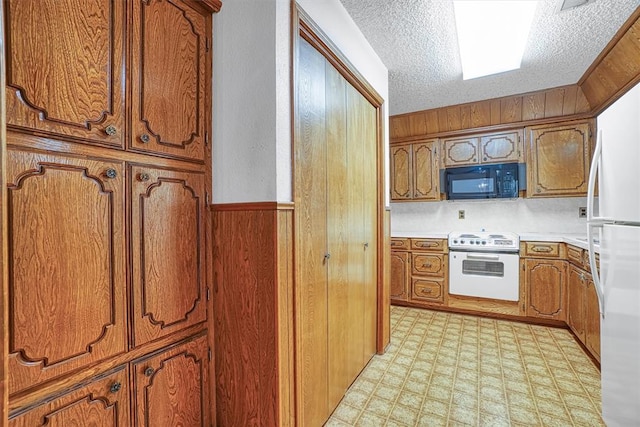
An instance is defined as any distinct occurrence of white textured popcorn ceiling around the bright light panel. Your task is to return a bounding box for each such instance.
[340,0,640,115]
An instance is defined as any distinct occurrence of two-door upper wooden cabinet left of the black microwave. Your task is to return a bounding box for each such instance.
[391,140,440,201]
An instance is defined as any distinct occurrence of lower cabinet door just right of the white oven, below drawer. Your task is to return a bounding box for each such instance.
[525,259,566,320]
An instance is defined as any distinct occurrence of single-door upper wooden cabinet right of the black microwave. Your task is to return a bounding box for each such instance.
[526,121,592,197]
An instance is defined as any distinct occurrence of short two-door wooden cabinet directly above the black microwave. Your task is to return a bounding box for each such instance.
[442,130,523,167]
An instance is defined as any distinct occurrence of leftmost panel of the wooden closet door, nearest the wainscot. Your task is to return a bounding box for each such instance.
[294,40,328,426]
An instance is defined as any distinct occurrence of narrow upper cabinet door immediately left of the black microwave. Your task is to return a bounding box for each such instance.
[413,140,440,200]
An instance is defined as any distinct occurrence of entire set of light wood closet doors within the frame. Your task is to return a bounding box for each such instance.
[294,32,378,425]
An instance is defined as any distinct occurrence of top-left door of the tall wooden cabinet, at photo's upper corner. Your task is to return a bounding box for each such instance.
[5,0,126,147]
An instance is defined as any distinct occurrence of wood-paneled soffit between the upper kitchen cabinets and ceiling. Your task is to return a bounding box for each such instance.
[389,8,640,142]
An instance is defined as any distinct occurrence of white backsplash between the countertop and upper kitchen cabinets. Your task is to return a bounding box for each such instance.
[391,197,587,234]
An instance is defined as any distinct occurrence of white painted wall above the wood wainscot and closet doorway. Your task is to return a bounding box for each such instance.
[213,0,389,203]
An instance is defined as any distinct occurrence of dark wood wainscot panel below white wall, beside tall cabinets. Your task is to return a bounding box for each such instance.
[212,202,295,426]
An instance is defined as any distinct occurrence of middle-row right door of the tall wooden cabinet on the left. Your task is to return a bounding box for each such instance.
[130,165,207,346]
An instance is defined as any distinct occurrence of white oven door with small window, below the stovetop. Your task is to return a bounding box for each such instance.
[449,251,520,301]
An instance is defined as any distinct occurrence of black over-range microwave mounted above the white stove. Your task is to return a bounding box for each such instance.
[440,163,527,200]
